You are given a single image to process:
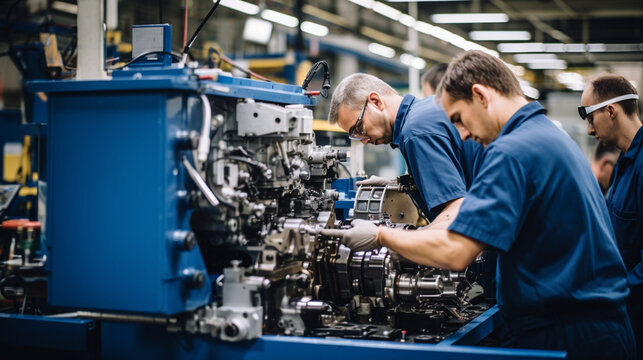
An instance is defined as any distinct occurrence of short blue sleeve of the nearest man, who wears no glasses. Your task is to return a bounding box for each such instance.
[449,149,534,251]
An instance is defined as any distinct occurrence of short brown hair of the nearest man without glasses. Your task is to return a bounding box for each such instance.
[437,50,524,101]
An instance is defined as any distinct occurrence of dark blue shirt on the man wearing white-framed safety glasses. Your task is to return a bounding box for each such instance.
[607,127,643,286]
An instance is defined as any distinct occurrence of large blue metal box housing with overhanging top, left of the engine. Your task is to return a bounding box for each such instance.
[28,69,312,315]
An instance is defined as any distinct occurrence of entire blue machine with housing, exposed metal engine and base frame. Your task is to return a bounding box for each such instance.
[0,17,564,358]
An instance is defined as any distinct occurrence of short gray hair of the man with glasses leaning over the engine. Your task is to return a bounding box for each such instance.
[328,73,397,124]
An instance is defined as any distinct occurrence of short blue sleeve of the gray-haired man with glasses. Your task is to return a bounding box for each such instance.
[401,134,466,215]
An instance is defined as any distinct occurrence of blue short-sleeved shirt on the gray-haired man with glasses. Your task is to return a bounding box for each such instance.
[391,95,484,221]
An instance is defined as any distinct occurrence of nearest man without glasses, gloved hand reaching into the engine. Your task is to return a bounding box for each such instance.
[324,51,635,359]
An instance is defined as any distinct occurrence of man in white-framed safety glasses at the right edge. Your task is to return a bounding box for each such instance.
[578,75,643,358]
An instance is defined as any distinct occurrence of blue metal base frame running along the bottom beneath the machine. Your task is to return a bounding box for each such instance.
[0,307,566,360]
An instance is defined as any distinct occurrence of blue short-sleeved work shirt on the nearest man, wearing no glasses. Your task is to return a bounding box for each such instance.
[449,102,629,329]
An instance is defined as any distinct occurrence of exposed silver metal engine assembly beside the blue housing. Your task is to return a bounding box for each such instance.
[184,95,488,341]
